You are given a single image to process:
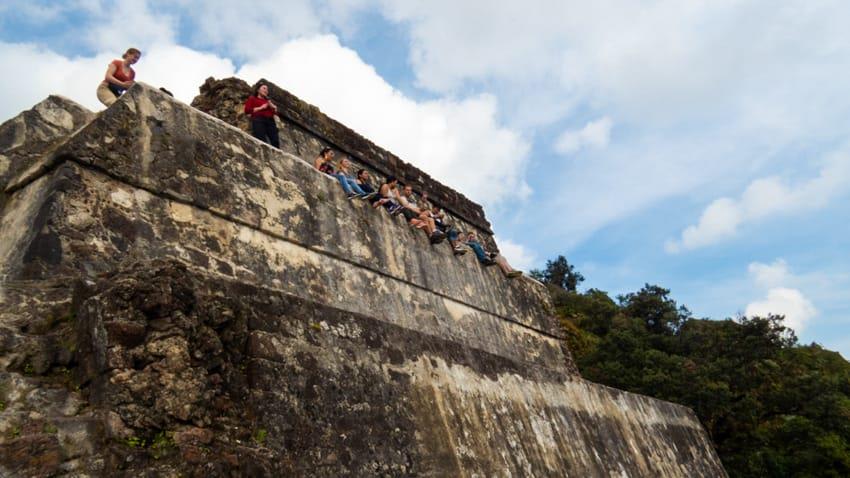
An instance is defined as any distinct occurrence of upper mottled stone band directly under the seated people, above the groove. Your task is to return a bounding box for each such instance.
[1,84,560,335]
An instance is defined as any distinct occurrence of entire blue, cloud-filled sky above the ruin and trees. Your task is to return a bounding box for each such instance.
[0,0,850,357]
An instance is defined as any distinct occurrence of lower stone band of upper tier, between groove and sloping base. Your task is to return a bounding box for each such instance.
[0,162,574,373]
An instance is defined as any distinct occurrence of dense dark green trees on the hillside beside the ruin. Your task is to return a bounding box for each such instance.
[532,256,850,477]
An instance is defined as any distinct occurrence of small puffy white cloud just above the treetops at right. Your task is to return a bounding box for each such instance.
[744,259,818,333]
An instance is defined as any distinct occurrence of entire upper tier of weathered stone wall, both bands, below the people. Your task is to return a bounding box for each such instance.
[4,84,571,367]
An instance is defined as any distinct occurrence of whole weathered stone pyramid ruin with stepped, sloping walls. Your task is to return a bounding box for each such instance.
[0,79,726,477]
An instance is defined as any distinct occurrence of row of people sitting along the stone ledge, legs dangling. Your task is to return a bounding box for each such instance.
[313,148,522,279]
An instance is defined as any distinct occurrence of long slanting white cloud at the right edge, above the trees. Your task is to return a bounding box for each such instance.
[665,149,850,253]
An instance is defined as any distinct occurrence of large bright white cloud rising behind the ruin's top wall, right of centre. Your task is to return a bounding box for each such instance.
[239,35,530,204]
